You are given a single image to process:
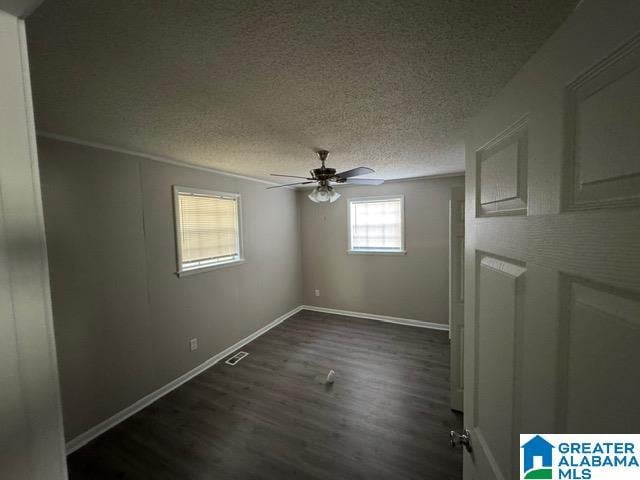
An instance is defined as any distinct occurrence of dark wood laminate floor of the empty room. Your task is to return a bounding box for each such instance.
[68,311,462,480]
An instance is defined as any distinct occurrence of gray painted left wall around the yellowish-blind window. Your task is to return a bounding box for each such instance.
[38,137,302,439]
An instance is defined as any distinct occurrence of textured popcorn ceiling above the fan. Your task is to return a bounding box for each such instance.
[28,0,576,179]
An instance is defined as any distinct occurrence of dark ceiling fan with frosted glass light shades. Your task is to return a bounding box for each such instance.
[268,150,384,203]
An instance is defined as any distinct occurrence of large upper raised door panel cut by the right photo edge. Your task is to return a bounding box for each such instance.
[565,36,640,209]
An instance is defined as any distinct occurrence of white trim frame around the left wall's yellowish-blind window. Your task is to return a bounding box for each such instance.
[173,185,245,277]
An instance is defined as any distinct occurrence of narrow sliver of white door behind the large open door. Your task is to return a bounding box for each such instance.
[449,187,464,412]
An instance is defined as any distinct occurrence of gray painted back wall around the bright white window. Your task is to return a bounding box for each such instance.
[298,176,464,323]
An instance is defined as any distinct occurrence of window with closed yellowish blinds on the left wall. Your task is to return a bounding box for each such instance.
[174,186,243,275]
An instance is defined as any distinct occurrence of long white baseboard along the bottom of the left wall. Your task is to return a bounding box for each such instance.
[67,306,303,455]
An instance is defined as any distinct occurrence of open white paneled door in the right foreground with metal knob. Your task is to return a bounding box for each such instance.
[464,0,640,480]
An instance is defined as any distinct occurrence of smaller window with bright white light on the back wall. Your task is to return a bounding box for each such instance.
[349,196,405,254]
